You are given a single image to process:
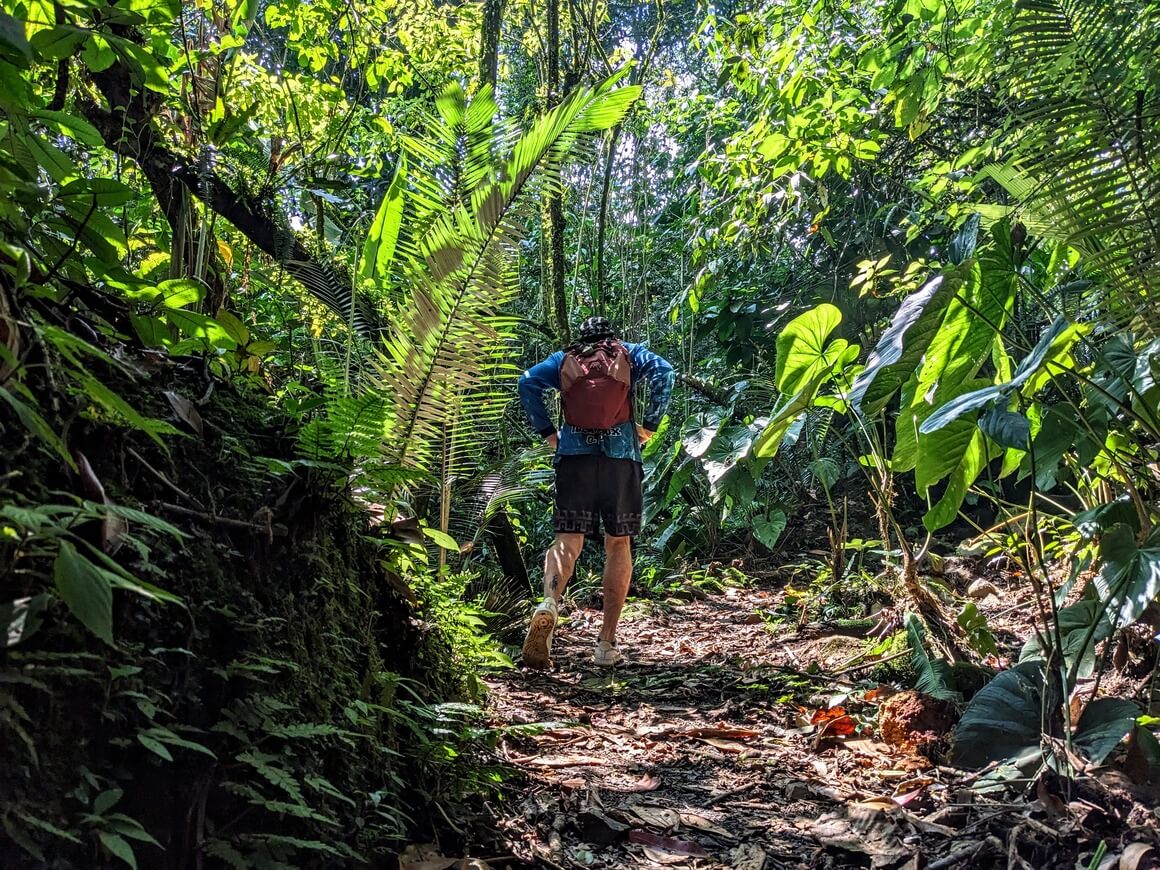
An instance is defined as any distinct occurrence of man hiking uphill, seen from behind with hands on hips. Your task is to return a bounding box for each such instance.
[520,317,673,668]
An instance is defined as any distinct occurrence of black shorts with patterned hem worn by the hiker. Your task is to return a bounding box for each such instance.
[552,455,643,537]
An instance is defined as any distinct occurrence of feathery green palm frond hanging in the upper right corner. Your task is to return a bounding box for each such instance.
[993,0,1160,338]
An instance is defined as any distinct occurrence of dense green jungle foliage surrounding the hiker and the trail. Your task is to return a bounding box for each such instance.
[0,0,1160,868]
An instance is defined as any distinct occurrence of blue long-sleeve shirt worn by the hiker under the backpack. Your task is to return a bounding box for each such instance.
[520,341,675,462]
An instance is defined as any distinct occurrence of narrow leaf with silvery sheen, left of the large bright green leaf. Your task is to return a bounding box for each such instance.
[850,273,962,416]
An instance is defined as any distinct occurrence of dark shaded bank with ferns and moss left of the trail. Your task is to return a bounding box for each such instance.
[0,361,498,868]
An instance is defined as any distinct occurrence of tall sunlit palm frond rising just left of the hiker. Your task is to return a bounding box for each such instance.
[374,74,639,479]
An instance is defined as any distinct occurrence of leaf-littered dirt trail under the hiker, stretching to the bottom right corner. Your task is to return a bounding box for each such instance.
[438,580,1155,870]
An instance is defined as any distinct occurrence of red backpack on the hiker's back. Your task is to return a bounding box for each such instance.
[560,339,632,429]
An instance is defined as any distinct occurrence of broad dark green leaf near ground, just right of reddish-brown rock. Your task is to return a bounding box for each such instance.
[951,661,1043,769]
